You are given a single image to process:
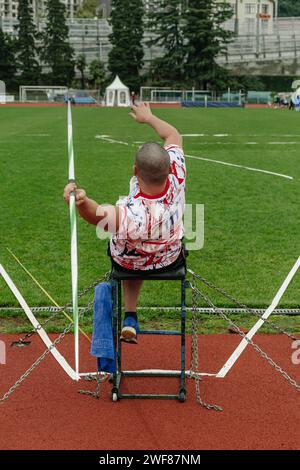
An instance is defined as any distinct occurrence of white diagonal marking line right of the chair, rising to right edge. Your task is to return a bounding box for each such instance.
[216,256,300,378]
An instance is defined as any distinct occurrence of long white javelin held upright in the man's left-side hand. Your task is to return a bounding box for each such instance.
[68,100,79,375]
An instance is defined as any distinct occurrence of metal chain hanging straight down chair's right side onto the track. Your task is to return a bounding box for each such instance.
[190,286,223,411]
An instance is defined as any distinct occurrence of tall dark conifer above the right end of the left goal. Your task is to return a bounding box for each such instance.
[42,0,75,86]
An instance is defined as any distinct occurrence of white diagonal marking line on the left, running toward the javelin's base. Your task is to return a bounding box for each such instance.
[0,264,80,380]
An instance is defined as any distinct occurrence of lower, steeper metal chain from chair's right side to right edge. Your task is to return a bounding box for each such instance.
[192,278,300,392]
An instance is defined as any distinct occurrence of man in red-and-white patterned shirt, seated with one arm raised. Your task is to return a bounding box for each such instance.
[64,103,186,343]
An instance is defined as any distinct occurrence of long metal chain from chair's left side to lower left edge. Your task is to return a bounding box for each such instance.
[0,273,109,404]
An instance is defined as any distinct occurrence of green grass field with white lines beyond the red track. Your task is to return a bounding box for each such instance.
[0,107,300,334]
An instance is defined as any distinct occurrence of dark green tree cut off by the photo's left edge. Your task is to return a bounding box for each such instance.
[0,28,17,89]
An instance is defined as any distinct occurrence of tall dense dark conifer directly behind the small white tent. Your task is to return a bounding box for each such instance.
[108,0,144,91]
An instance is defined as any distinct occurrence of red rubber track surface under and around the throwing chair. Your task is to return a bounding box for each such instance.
[0,335,300,450]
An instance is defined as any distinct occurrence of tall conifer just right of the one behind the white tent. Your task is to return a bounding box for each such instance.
[148,0,185,86]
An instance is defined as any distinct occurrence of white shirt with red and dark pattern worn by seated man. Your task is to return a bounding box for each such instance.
[110,145,186,270]
